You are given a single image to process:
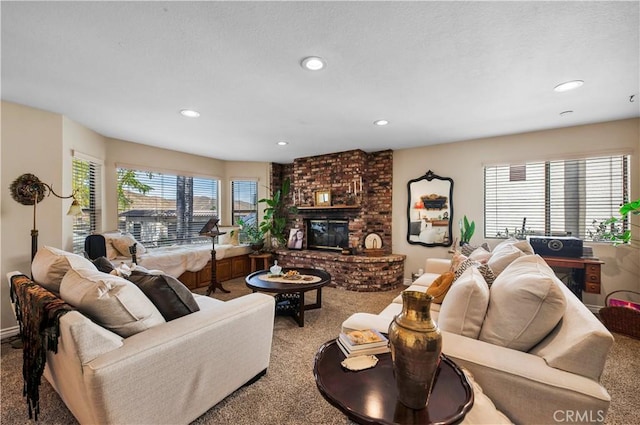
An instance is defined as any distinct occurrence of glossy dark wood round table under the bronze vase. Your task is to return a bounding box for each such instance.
[313,340,473,425]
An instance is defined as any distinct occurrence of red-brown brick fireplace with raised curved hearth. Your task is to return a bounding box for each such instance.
[271,150,404,291]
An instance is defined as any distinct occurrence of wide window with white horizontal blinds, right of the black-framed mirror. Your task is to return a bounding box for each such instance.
[484,155,629,239]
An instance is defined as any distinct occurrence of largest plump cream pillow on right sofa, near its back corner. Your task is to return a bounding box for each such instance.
[480,255,567,351]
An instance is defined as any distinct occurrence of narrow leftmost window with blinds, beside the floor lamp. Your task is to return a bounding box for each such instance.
[71,153,102,254]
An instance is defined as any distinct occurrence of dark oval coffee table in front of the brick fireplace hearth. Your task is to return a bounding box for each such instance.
[245,268,331,327]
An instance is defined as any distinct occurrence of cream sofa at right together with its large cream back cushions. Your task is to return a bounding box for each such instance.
[343,243,613,424]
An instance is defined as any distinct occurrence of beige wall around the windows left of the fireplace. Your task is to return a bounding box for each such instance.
[0,102,270,336]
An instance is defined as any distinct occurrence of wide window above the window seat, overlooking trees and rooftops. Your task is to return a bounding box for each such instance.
[118,168,219,247]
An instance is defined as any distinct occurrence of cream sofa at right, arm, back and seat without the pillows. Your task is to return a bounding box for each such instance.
[343,252,613,424]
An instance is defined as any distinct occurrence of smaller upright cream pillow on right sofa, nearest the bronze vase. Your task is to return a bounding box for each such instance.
[438,267,489,339]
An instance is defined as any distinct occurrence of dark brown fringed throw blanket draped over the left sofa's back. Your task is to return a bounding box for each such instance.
[11,275,73,421]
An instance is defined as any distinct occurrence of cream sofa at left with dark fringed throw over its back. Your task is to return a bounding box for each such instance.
[8,245,275,424]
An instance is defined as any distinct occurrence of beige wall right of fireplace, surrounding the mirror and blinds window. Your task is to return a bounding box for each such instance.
[393,119,640,305]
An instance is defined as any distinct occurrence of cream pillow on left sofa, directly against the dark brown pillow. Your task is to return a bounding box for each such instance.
[60,266,165,338]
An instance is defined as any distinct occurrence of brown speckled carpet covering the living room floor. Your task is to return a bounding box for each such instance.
[0,279,640,425]
